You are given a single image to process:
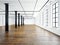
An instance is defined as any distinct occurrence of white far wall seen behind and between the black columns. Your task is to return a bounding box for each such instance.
[0,15,35,26]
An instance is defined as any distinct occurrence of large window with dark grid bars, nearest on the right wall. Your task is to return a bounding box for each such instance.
[52,3,58,27]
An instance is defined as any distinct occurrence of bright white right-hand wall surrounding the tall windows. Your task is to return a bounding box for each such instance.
[35,0,60,36]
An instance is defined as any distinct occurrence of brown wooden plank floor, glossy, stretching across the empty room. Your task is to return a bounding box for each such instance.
[0,25,60,45]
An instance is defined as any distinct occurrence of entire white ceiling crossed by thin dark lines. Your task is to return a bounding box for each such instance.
[0,0,47,15]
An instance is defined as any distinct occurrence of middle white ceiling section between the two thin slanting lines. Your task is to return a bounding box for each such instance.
[20,0,36,11]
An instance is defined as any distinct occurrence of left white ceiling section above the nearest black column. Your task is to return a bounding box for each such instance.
[0,0,22,11]
